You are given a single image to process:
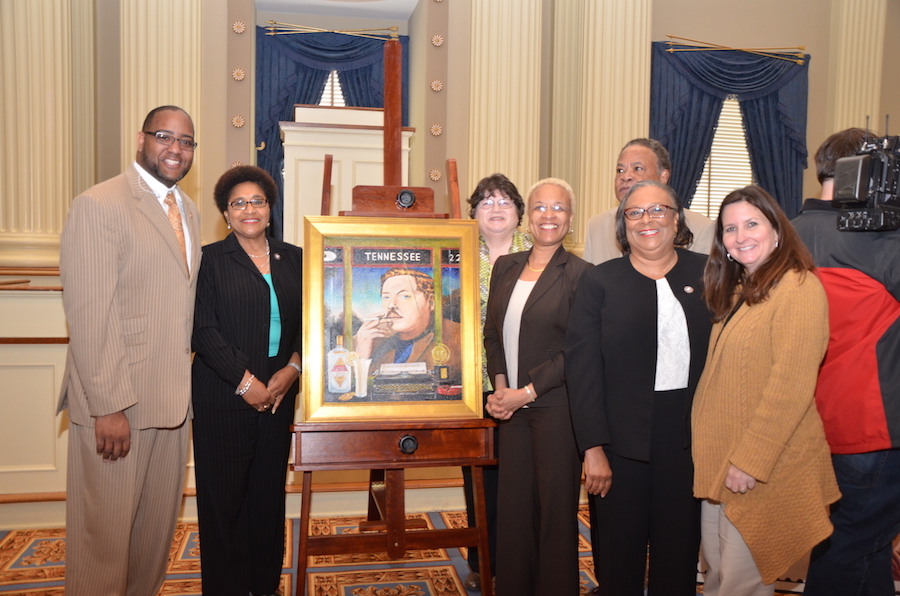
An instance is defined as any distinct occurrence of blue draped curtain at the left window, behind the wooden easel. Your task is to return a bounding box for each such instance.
[256,27,409,238]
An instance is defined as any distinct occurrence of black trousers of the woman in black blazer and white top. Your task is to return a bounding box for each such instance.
[590,390,700,596]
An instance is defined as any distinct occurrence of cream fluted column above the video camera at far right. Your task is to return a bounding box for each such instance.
[828,0,887,134]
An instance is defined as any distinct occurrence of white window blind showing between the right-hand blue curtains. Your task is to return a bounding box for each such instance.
[691,97,753,219]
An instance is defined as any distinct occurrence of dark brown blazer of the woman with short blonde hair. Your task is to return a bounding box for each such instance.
[484,246,592,407]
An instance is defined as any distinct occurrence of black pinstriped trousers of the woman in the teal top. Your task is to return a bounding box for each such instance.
[193,393,296,596]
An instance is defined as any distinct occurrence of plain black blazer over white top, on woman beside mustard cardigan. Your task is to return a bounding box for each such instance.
[565,249,712,461]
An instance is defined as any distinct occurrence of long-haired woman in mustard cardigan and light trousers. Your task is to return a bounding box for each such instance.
[692,186,840,596]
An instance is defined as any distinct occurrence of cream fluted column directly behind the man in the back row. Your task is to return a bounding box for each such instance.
[573,0,652,244]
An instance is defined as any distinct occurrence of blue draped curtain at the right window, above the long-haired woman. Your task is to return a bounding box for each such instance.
[650,42,810,217]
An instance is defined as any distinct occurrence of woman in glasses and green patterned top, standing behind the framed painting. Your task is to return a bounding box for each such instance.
[463,174,531,591]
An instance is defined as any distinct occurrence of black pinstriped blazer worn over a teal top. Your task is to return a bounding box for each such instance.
[191,233,303,410]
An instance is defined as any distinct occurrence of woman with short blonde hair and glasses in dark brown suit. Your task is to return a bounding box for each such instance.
[484,178,591,596]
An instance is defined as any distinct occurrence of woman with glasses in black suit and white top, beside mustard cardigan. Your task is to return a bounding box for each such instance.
[565,180,711,596]
